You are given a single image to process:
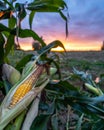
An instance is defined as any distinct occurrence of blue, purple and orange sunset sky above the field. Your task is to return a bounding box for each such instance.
[13,0,104,50]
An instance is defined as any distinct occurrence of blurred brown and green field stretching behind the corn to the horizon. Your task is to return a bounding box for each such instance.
[8,51,104,86]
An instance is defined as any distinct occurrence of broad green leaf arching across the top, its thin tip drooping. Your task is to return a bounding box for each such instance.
[27,0,69,36]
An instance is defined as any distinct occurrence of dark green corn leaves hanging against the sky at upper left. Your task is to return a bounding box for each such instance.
[0,0,68,60]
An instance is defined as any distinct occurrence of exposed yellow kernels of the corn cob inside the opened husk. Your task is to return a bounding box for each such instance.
[9,65,44,108]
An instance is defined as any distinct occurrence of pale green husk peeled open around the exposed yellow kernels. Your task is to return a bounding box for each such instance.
[0,59,49,130]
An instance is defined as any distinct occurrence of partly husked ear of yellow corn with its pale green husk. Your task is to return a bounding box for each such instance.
[0,55,50,130]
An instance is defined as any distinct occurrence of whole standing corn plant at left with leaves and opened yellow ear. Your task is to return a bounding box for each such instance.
[0,0,68,130]
